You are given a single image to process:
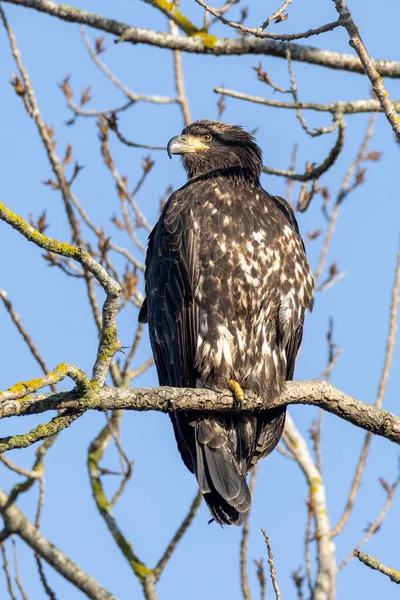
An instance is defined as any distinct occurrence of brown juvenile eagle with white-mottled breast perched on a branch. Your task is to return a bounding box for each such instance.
[139,120,313,525]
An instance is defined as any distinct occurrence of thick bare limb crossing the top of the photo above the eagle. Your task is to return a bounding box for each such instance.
[4,0,400,78]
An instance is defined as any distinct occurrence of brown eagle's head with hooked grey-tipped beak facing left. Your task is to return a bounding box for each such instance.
[167,120,262,182]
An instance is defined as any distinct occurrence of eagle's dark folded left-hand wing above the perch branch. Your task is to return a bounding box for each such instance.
[139,196,199,387]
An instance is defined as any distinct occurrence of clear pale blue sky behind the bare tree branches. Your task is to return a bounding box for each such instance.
[0,0,400,600]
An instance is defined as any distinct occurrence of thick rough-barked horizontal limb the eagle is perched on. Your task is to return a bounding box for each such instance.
[0,380,400,444]
